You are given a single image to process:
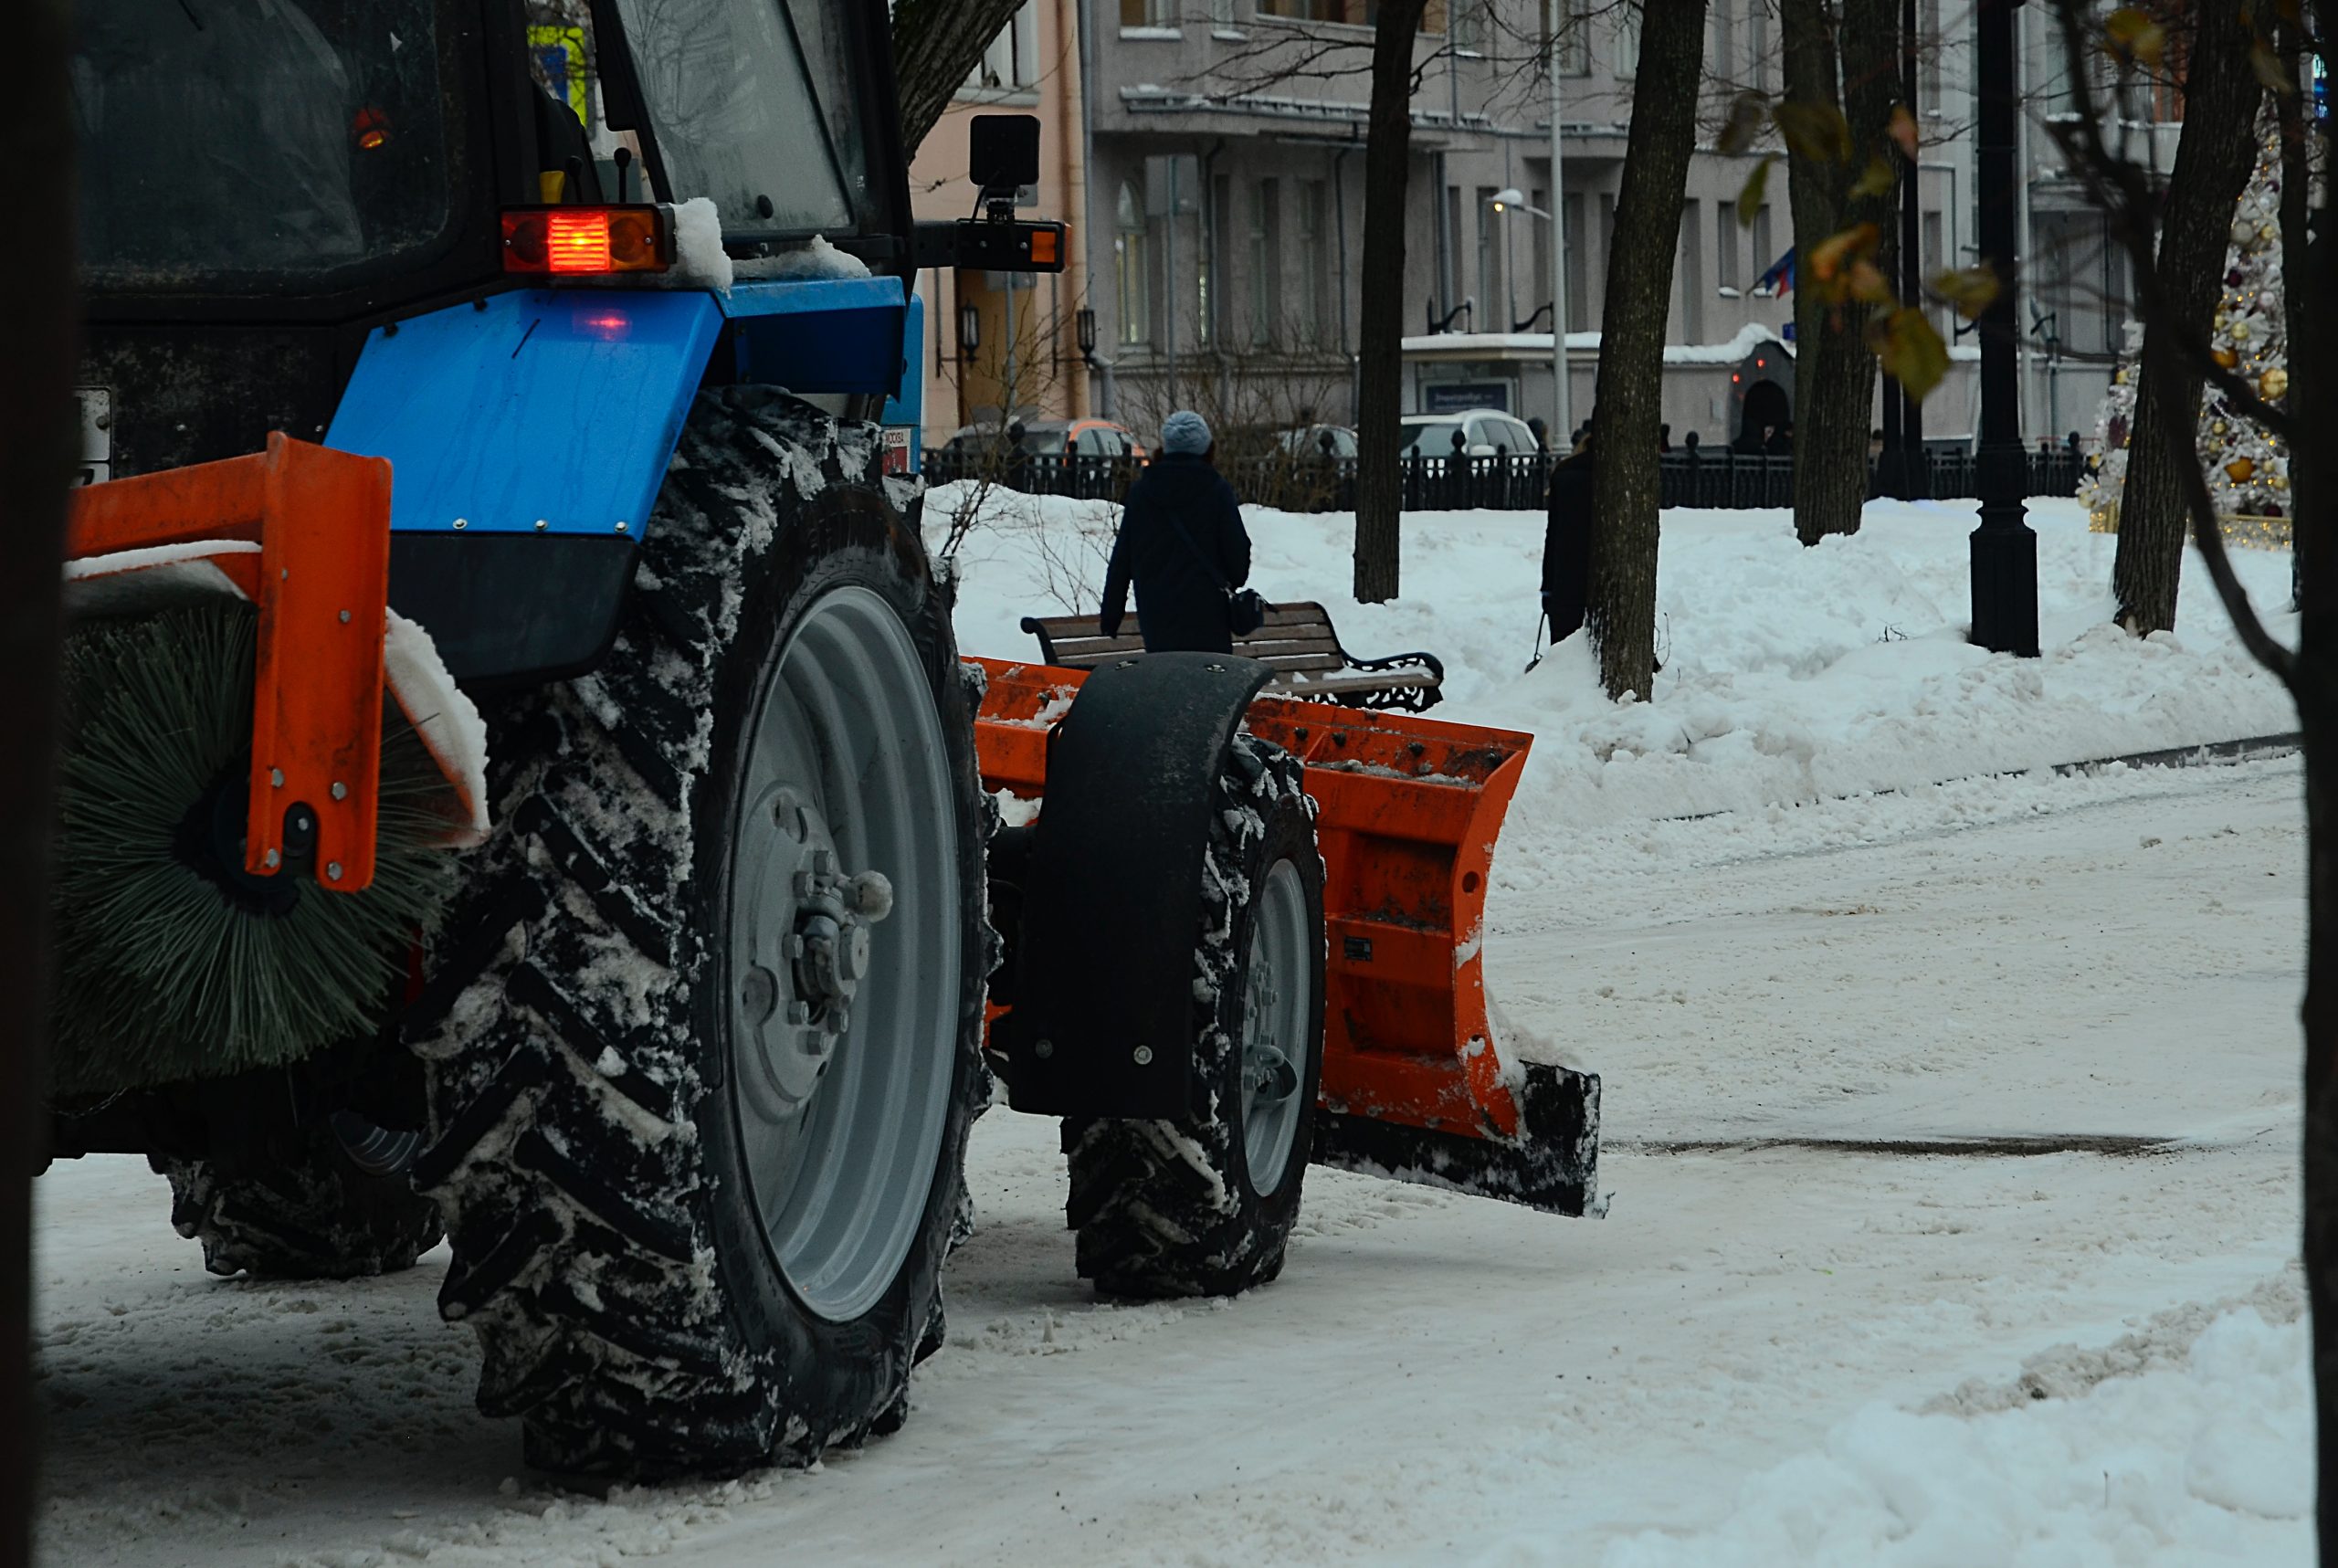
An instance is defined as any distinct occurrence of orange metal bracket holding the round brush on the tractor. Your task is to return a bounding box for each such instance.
[66,432,391,892]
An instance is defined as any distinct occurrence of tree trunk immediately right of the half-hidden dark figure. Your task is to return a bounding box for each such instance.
[1583,0,1704,697]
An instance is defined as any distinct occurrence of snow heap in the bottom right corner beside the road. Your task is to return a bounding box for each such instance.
[1580,1309,2314,1568]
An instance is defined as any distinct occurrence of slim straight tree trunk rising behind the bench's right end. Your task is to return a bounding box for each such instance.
[1356,0,1421,605]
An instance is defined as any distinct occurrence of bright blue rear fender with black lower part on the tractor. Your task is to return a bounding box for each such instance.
[325,279,917,680]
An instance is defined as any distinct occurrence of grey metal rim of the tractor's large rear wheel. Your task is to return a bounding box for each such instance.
[725,586,965,1322]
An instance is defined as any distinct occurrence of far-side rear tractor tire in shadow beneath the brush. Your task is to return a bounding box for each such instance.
[147,1112,442,1280]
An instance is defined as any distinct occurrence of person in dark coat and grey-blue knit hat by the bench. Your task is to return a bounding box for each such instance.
[1097,409,1251,654]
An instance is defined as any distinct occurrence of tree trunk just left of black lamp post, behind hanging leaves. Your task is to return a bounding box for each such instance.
[1779,0,1905,544]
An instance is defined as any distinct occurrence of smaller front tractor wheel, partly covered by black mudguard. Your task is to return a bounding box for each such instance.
[1064,733,1323,1297]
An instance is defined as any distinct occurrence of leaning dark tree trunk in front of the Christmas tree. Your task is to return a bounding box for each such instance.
[2112,0,2253,636]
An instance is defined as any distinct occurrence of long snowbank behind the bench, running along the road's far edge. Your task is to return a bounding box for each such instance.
[926,486,2296,868]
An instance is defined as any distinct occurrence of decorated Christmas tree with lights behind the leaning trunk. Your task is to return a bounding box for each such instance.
[2080,112,2289,544]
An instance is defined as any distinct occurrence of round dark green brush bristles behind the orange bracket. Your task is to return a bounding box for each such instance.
[51,601,456,1099]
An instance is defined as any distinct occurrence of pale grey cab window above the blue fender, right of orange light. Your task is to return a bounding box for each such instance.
[617,0,868,234]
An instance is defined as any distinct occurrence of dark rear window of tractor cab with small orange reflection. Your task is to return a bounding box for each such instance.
[72,0,451,292]
